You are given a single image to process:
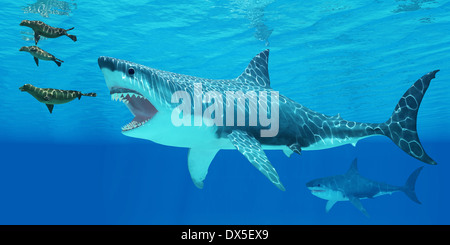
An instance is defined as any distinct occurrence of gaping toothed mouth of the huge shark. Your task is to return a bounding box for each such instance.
[110,87,158,132]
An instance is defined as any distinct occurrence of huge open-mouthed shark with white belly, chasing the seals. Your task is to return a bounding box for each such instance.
[98,50,439,190]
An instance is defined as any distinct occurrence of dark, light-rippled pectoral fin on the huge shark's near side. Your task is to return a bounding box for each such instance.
[228,130,286,191]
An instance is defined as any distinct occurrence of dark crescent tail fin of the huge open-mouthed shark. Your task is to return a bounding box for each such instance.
[381,70,439,165]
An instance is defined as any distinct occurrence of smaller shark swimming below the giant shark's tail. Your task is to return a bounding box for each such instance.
[306,159,423,217]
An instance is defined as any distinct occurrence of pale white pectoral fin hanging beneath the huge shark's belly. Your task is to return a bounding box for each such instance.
[188,148,219,189]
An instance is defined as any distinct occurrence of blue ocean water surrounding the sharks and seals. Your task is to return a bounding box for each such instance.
[0,0,450,224]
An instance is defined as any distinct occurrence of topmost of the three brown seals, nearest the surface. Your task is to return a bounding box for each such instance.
[20,20,77,45]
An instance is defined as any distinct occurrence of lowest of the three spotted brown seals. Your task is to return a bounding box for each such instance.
[19,84,97,113]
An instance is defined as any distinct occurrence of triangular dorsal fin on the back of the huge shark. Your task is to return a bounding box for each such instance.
[236,49,270,88]
